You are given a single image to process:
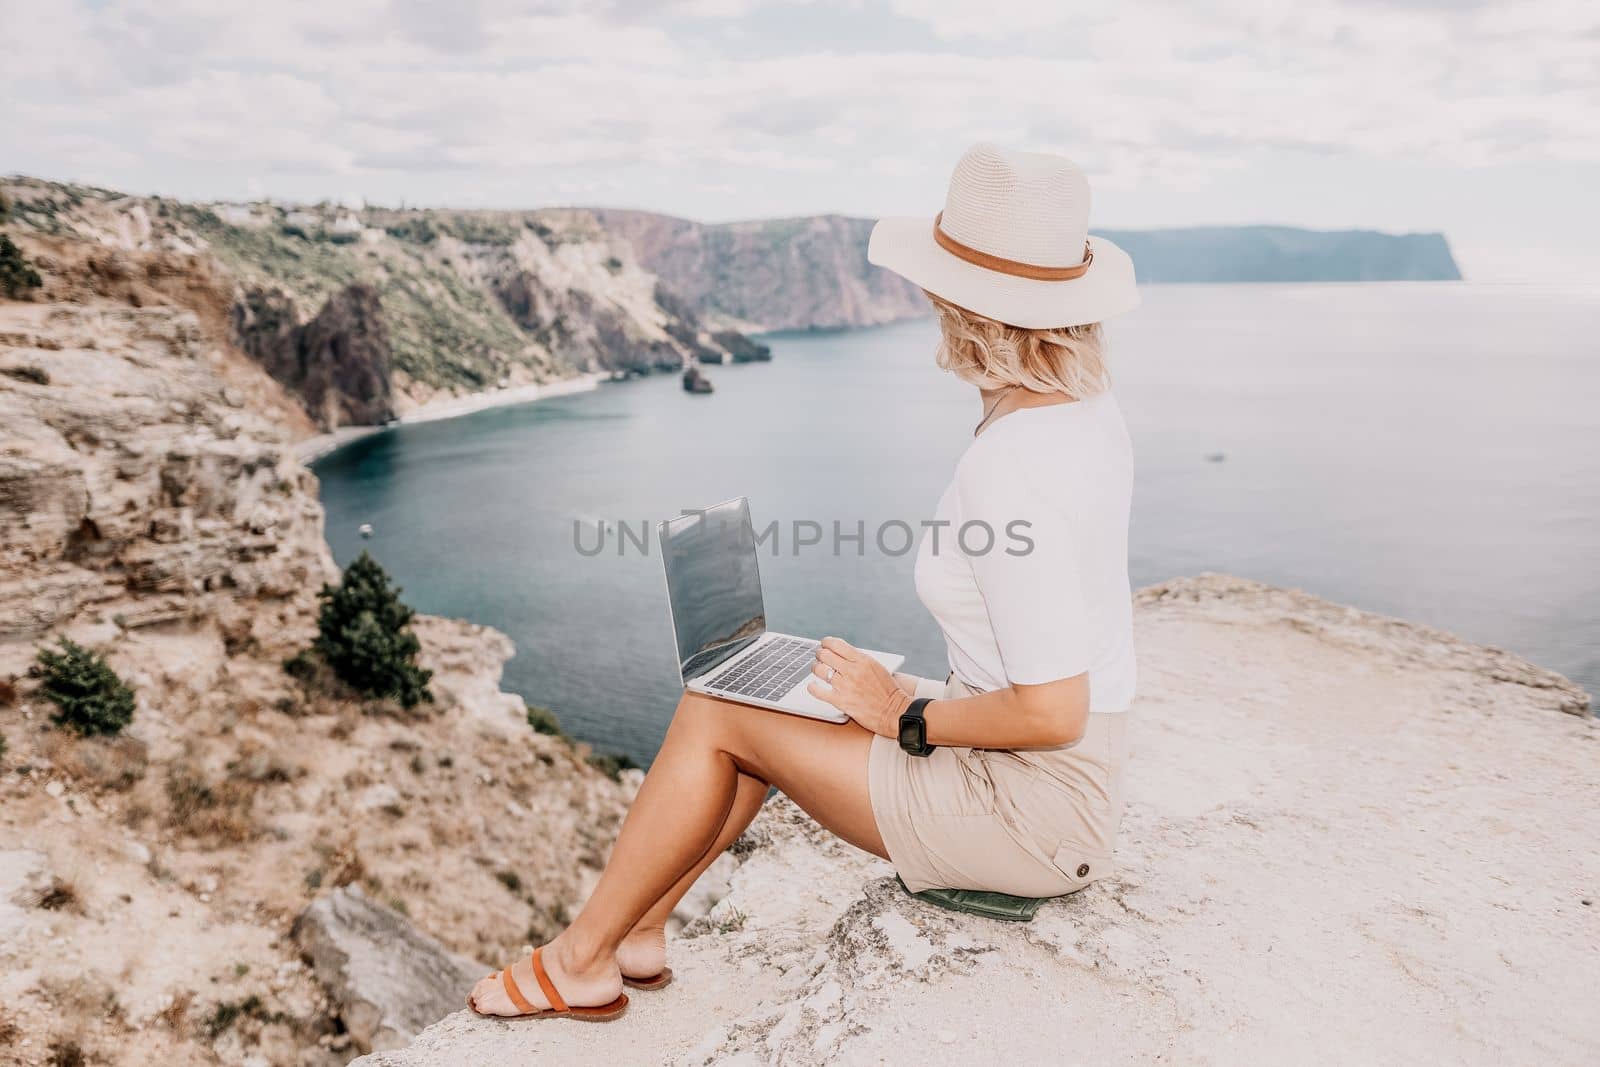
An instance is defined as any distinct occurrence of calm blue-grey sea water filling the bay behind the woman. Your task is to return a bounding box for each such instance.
[317,283,1600,760]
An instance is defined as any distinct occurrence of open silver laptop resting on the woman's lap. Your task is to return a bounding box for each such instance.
[656,496,906,723]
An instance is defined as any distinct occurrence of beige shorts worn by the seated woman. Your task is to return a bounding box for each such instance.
[867,677,1128,896]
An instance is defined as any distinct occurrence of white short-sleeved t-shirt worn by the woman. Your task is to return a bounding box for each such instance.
[917,392,1136,712]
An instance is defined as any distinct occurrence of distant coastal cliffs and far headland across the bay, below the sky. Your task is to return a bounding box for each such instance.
[0,178,1461,430]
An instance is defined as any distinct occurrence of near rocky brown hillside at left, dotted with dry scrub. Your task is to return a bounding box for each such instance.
[0,273,630,1067]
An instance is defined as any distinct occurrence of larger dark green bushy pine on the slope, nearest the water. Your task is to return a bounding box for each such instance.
[312,552,434,707]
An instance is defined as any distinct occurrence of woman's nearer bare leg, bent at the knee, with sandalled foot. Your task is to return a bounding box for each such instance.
[472,693,886,1014]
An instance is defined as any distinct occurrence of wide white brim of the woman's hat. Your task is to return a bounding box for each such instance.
[867,218,1139,330]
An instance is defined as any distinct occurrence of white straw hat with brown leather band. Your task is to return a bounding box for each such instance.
[867,144,1139,330]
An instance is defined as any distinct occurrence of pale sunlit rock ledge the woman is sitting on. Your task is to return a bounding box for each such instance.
[358,576,1600,1067]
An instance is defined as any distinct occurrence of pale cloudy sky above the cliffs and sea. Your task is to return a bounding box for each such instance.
[0,0,1600,285]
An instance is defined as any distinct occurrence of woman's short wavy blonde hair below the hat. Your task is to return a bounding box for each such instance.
[928,293,1110,400]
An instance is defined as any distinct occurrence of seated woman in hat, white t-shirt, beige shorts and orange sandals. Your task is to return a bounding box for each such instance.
[469,144,1138,1019]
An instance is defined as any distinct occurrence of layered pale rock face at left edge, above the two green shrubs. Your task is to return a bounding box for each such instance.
[0,301,331,641]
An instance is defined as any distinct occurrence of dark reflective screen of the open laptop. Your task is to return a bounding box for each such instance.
[661,496,766,681]
